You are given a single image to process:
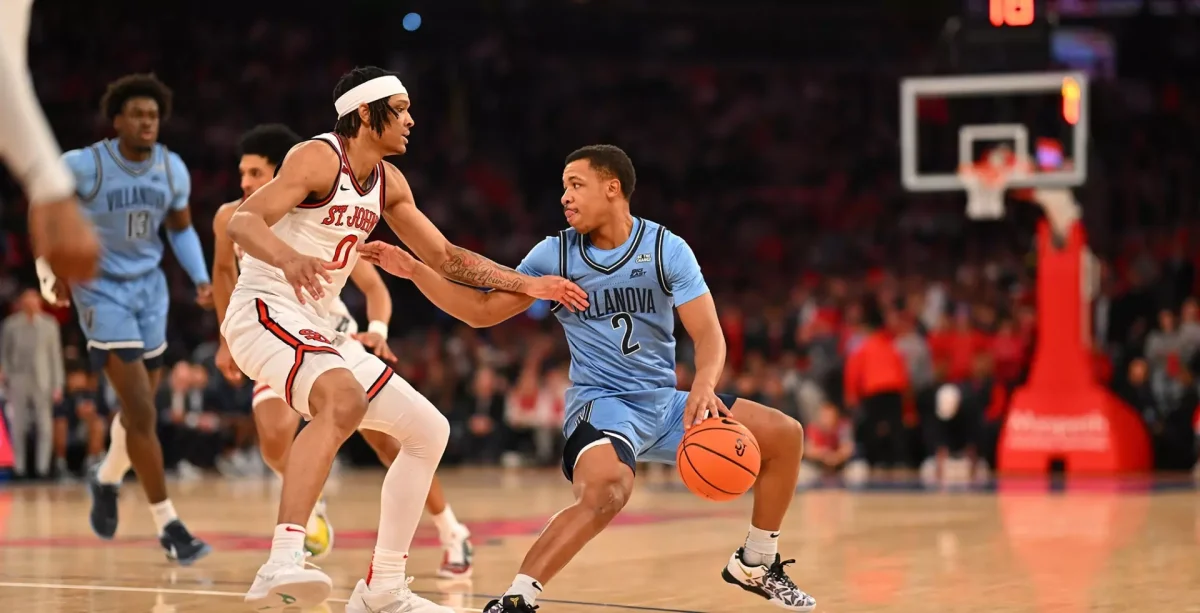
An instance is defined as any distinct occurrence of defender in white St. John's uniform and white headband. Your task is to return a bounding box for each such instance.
[221,67,587,613]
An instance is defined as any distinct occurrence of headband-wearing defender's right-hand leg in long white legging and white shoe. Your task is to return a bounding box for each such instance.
[346,356,454,613]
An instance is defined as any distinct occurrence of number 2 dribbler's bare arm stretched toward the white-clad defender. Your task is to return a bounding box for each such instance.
[359,242,535,327]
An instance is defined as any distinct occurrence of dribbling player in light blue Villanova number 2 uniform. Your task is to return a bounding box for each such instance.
[362,145,816,613]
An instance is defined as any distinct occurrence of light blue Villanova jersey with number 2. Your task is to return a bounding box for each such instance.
[517,217,708,408]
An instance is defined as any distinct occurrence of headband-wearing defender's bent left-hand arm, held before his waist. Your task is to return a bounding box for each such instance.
[226,140,341,305]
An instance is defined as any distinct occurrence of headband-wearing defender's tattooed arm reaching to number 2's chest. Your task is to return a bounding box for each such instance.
[384,164,588,311]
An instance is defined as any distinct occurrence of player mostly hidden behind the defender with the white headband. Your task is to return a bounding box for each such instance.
[212,124,472,578]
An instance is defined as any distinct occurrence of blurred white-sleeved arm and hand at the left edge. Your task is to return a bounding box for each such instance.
[0,0,100,282]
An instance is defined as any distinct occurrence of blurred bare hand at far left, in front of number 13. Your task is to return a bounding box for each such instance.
[29,197,100,283]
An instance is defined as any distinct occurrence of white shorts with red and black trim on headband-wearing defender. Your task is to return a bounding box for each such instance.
[221,295,394,416]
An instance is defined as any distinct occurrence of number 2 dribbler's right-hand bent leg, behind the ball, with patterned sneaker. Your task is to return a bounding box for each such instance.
[643,391,816,611]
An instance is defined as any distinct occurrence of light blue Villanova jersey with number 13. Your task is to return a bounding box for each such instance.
[62,139,192,278]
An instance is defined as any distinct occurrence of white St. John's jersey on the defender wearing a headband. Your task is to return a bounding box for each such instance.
[234,133,386,327]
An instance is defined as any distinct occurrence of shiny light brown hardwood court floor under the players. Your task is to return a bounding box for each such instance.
[0,470,1200,613]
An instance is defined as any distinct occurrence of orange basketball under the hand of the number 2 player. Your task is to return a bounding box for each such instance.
[676,417,762,503]
